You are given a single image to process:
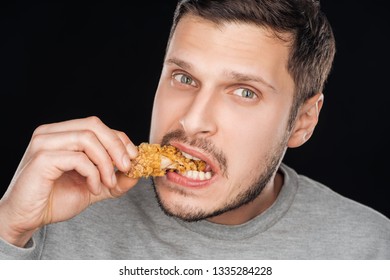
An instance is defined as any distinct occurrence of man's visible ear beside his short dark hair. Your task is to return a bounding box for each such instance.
[288,92,324,148]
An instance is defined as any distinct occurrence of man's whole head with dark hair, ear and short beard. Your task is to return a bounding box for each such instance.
[150,0,335,223]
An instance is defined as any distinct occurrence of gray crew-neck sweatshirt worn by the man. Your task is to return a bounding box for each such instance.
[0,164,390,260]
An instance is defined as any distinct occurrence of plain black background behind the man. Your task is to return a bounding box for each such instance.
[0,0,390,217]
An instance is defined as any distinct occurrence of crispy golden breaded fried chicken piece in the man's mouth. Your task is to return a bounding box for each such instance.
[126,142,206,178]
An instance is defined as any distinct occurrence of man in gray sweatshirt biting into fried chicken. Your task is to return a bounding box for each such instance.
[0,0,390,259]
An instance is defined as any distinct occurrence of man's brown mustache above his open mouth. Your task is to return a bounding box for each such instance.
[161,129,227,176]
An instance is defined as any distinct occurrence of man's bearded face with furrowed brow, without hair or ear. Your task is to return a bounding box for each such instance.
[150,16,294,223]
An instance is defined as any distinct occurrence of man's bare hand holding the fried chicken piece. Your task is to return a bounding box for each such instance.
[0,117,137,247]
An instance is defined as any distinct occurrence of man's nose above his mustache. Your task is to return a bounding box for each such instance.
[179,92,218,137]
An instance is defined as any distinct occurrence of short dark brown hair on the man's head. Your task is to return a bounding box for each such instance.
[168,0,336,128]
